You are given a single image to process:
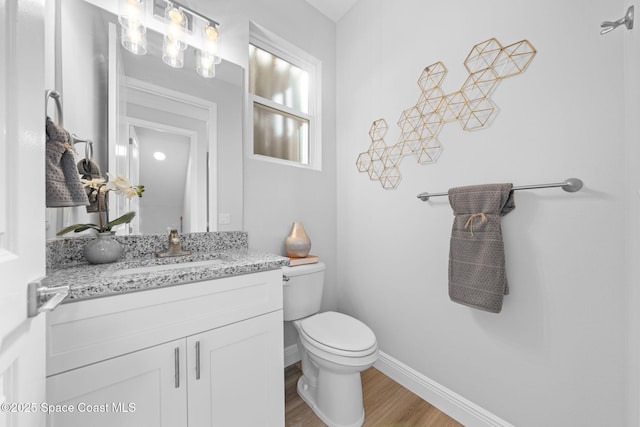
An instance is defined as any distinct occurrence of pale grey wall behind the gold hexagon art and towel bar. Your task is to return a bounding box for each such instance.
[337,0,640,426]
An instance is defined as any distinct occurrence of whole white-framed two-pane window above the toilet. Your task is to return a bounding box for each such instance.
[249,24,321,170]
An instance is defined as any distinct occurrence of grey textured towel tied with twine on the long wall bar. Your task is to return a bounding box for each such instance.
[449,184,516,313]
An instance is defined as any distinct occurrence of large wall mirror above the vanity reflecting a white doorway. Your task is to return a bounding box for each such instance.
[49,0,244,234]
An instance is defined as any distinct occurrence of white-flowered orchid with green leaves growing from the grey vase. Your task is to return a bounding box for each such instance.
[56,173,144,236]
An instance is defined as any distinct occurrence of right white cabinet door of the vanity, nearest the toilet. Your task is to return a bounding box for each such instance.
[187,310,284,427]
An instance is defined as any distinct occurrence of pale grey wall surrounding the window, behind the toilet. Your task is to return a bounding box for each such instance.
[191,0,337,345]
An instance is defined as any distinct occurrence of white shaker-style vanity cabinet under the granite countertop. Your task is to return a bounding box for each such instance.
[47,270,284,427]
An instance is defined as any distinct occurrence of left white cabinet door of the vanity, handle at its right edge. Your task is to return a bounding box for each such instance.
[47,339,187,427]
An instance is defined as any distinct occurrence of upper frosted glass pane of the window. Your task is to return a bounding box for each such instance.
[249,45,309,114]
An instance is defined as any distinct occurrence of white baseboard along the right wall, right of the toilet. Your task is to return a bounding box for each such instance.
[375,352,513,427]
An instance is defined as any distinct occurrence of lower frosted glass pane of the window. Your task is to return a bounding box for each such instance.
[253,102,309,164]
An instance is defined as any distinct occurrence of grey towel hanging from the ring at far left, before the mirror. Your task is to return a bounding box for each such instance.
[45,117,89,208]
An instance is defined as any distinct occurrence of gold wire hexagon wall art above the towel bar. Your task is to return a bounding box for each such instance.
[356,38,536,189]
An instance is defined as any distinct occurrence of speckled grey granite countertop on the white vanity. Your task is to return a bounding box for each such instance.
[42,249,289,304]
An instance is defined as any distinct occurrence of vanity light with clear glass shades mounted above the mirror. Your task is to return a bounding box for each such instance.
[118,0,222,78]
